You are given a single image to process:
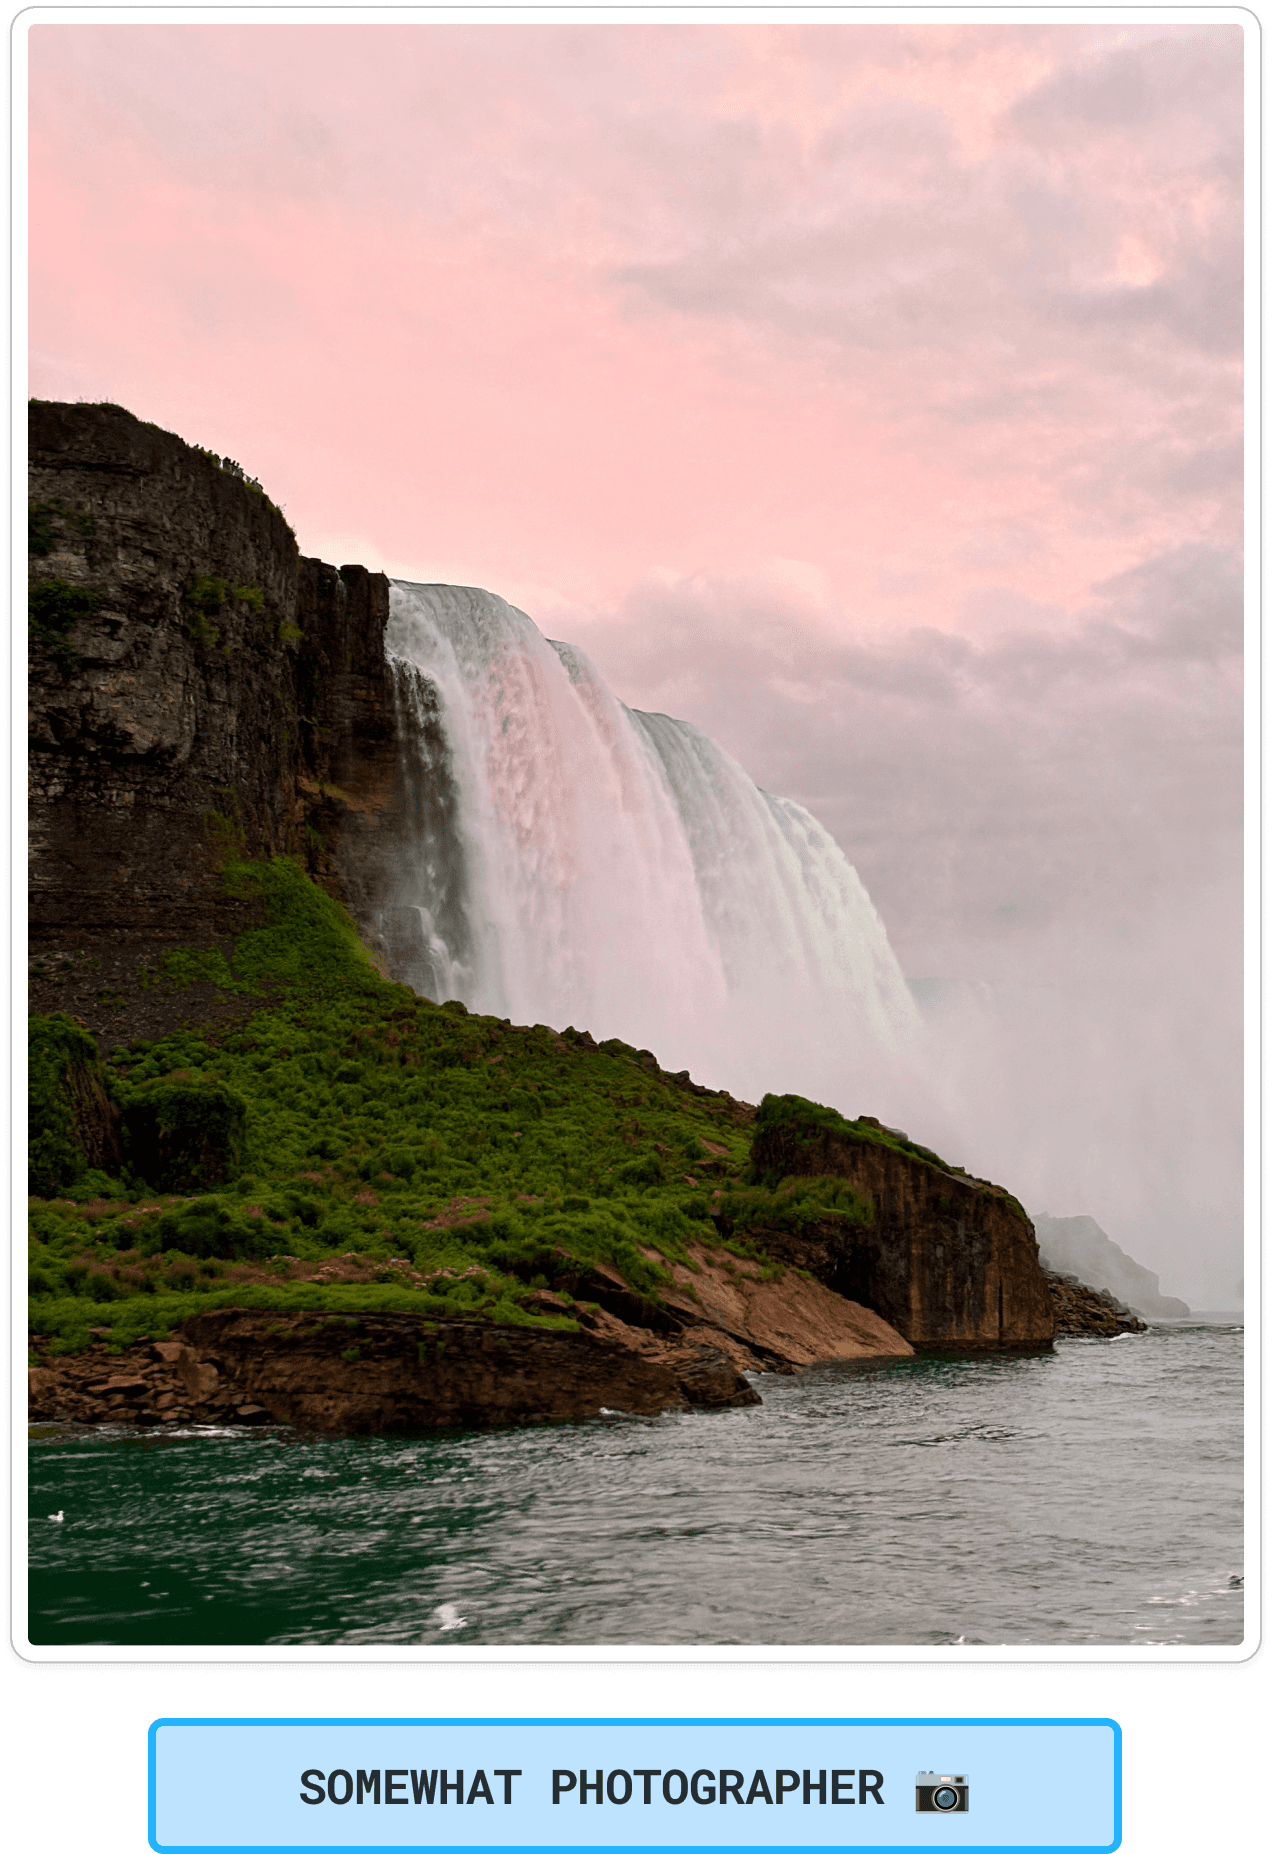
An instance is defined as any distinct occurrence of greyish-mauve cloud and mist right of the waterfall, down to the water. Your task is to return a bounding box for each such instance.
[549,547,1242,1307]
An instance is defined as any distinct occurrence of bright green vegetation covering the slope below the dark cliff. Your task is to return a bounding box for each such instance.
[30,858,767,1352]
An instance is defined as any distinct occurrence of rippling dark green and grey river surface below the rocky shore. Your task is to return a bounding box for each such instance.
[30,1322,1244,1650]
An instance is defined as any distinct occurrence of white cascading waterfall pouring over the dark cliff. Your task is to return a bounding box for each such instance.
[386,580,918,1112]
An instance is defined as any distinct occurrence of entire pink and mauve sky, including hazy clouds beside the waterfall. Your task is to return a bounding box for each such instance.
[30,9,1242,1305]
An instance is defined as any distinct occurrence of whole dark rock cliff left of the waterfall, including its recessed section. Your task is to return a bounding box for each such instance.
[30,402,402,1035]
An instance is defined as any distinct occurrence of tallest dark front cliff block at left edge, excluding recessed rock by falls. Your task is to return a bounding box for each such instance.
[30,404,300,931]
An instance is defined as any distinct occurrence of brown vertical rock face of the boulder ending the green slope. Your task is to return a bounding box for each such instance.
[753,1109,1055,1350]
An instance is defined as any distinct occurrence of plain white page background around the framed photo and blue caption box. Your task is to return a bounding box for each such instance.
[0,0,1272,1854]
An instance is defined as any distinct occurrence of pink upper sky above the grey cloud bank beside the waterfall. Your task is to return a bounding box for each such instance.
[32,15,1240,630]
